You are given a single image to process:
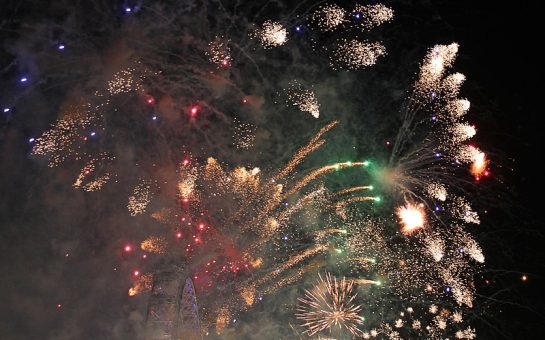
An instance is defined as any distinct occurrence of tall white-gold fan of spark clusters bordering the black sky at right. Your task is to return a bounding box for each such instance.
[374,44,486,314]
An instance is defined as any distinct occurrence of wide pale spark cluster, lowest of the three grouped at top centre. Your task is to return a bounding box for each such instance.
[330,40,386,70]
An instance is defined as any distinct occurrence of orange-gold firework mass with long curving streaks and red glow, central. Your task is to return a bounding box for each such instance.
[136,122,376,332]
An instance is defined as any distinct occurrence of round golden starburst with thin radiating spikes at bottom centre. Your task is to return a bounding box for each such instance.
[296,273,363,336]
